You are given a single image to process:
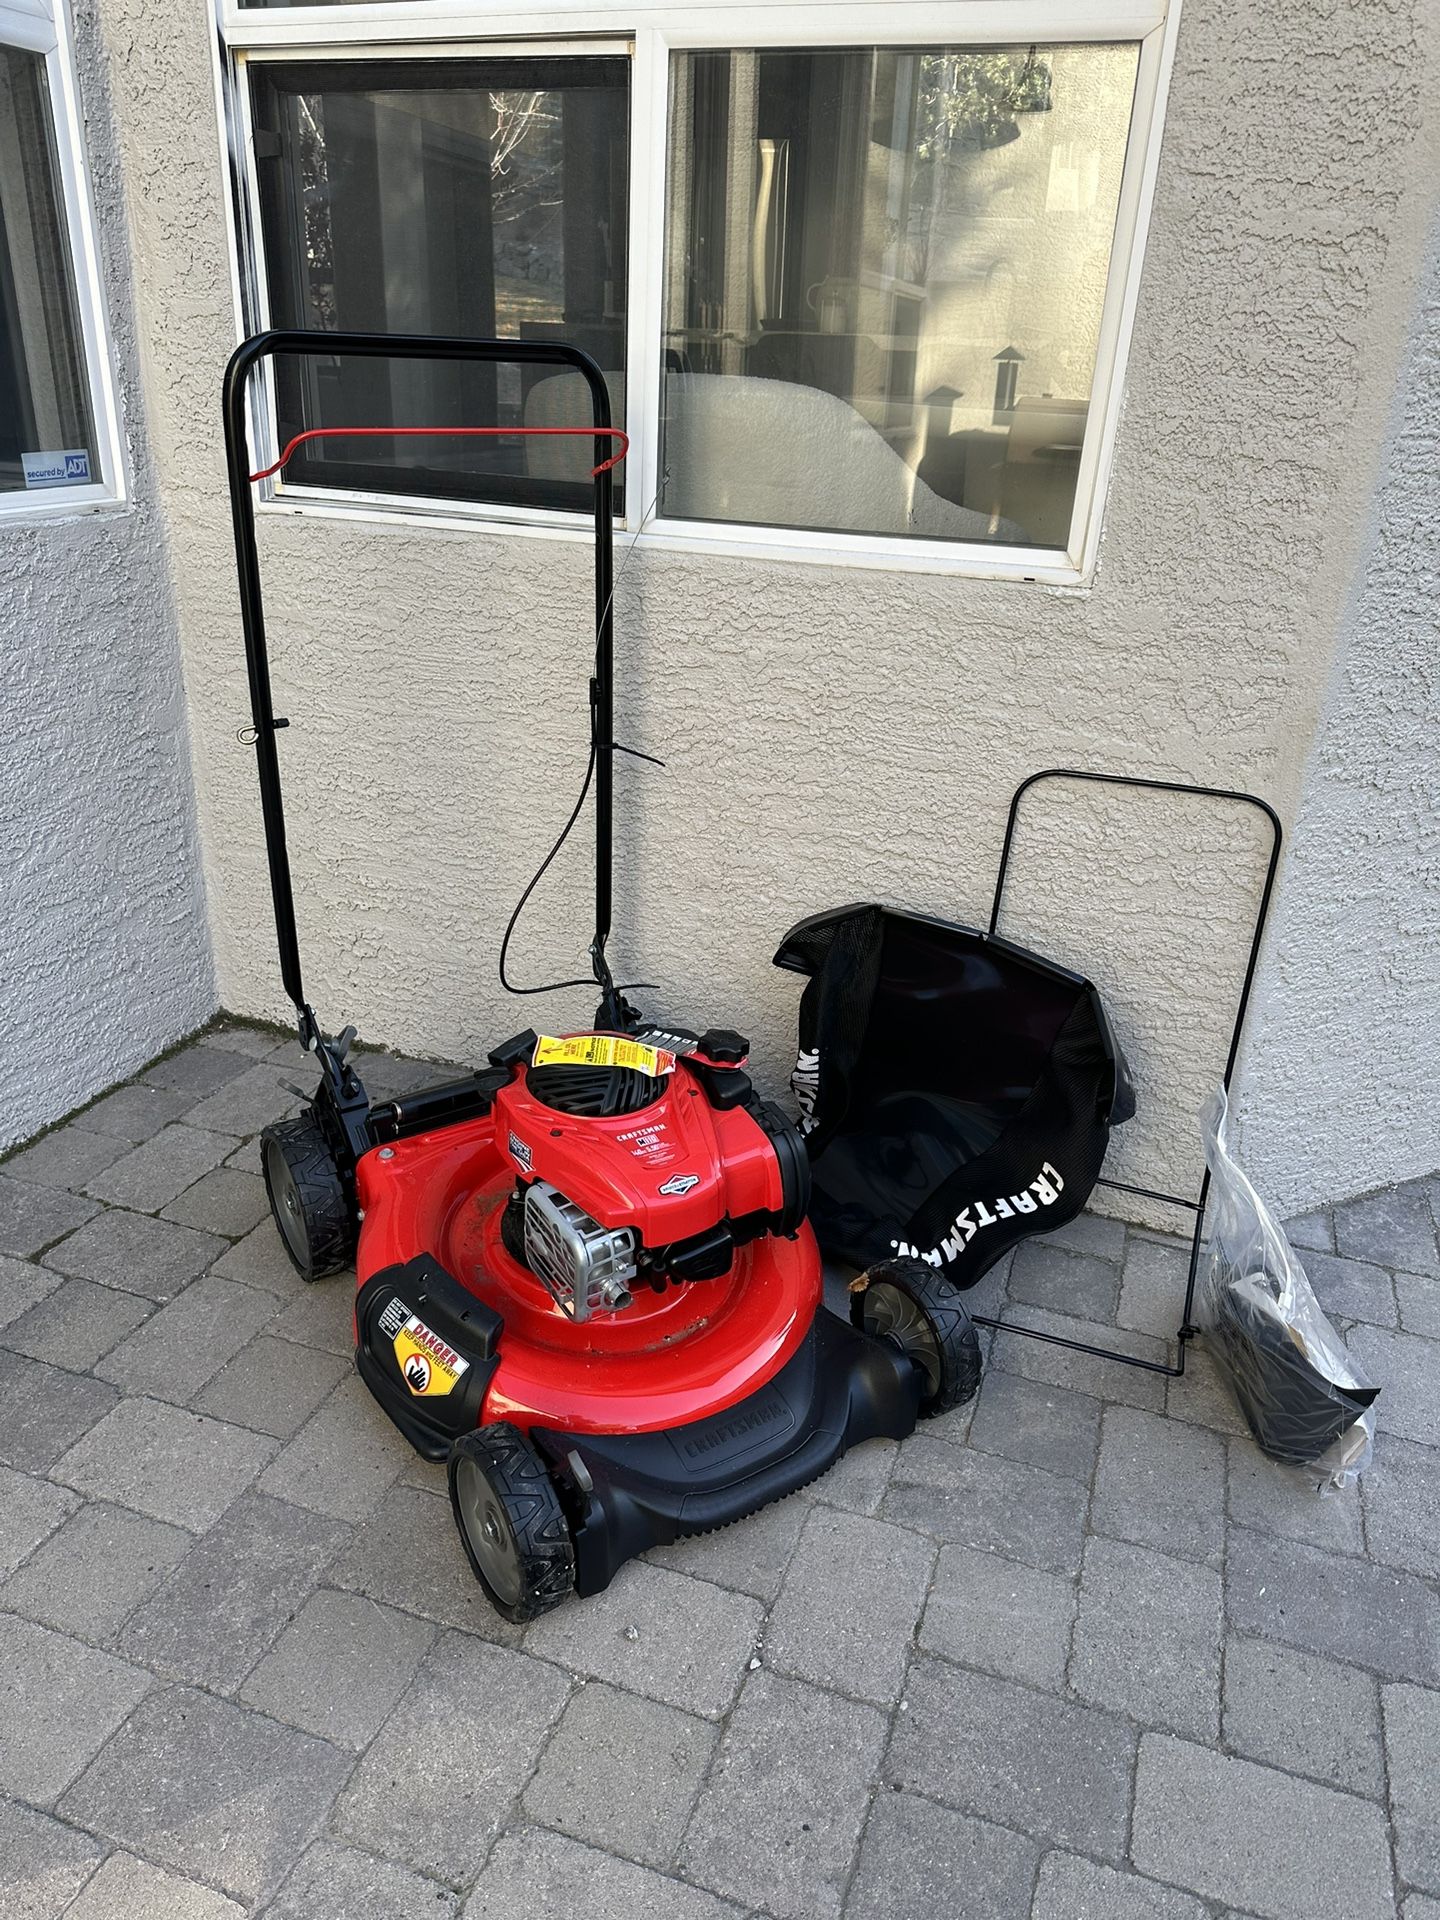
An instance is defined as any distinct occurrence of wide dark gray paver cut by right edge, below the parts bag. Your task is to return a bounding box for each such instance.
[1225,1526,1440,1686]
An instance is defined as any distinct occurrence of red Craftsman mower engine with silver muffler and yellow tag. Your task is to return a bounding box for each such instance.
[492,1029,810,1321]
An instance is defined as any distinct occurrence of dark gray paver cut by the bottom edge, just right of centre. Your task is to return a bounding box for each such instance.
[845,1793,1039,1920]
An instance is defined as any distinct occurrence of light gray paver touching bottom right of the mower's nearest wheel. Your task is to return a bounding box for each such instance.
[524,1561,762,1720]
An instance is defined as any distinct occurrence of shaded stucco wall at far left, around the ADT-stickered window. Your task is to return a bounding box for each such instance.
[0,0,215,1148]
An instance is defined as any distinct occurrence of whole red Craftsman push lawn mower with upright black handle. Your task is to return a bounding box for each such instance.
[225,332,979,1620]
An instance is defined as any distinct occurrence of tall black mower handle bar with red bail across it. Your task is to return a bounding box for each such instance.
[223,328,628,1050]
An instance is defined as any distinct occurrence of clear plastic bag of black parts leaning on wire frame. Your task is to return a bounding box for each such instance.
[1198,1091,1379,1488]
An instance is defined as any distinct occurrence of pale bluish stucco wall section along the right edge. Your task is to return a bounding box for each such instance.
[1252,206,1440,1200]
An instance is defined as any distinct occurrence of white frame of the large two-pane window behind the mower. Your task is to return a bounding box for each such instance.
[214,0,1181,588]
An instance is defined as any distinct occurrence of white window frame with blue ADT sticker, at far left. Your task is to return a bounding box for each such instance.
[0,0,125,522]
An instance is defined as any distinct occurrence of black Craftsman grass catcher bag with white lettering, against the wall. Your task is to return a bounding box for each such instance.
[776,906,1135,1286]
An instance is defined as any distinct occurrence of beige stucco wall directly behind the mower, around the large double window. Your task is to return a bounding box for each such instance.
[98,0,1440,1202]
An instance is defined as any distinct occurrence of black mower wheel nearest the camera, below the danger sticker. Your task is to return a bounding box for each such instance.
[449,1421,574,1624]
